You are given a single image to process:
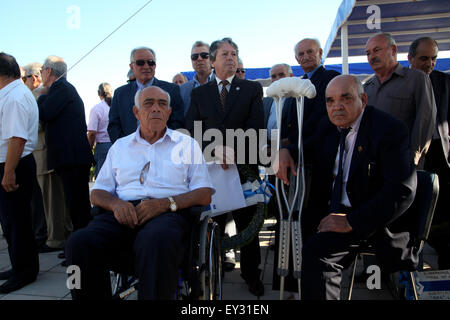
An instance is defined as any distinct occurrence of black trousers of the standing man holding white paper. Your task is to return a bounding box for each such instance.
[214,206,261,281]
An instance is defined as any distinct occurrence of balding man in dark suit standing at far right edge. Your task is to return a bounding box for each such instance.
[408,37,450,269]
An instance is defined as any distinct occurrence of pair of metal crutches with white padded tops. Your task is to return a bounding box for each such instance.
[267,78,316,300]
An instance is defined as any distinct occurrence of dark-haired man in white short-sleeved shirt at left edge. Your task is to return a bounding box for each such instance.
[0,52,39,294]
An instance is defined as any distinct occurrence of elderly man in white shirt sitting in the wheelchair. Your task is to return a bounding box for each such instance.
[66,86,214,300]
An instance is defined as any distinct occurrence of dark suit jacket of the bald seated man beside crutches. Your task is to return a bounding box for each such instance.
[302,106,417,239]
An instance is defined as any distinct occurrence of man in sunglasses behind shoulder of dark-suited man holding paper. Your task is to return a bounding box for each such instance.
[180,41,214,115]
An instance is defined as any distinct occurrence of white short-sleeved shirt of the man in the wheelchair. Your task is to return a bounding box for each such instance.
[94,127,215,201]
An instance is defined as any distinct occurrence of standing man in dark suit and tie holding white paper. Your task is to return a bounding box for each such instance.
[186,38,264,296]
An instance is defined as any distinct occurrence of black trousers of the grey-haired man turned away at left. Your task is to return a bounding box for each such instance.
[56,165,92,231]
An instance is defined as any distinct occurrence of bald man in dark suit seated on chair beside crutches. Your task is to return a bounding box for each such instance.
[277,75,417,300]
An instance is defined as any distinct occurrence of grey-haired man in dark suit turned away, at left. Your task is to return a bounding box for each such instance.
[38,56,93,234]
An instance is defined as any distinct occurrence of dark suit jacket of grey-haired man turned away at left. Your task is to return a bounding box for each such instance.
[38,78,94,170]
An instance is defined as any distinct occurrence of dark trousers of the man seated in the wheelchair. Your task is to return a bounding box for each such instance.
[65,212,190,300]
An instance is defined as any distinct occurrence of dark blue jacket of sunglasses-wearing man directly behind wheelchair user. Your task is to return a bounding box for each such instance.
[108,78,184,142]
